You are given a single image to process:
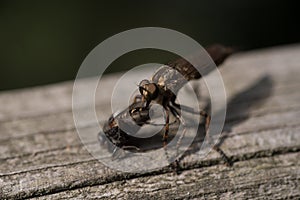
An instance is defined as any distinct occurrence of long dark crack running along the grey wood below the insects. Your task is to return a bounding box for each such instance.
[0,145,300,199]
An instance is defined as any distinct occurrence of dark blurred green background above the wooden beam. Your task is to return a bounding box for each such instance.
[0,0,300,90]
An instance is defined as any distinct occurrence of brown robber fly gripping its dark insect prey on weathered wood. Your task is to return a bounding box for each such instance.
[99,45,233,165]
